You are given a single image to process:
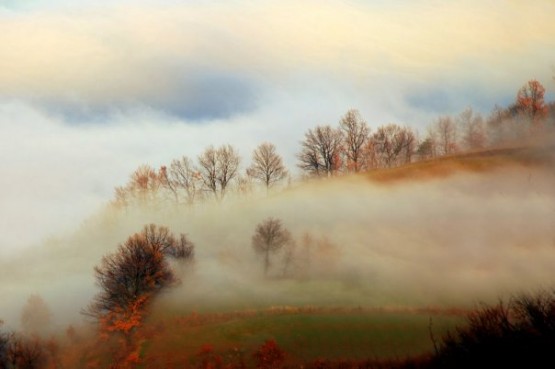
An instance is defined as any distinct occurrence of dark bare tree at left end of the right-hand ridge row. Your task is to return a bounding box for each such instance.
[297,126,343,177]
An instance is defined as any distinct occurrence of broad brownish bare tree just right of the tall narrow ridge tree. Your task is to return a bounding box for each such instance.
[372,124,416,168]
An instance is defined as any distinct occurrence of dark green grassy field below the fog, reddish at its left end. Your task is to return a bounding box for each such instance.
[137,309,463,368]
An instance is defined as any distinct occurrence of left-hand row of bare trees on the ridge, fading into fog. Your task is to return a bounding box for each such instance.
[114,143,288,206]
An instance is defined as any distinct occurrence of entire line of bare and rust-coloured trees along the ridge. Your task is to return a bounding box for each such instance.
[113,80,555,208]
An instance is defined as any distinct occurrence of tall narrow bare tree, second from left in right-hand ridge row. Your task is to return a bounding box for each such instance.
[339,109,370,172]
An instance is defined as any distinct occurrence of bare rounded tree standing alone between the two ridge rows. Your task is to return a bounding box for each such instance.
[247,142,287,190]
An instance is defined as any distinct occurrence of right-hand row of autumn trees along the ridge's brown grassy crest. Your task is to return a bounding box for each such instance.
[297,80,555,177]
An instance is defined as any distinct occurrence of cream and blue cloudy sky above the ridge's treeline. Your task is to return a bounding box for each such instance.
[0,0,555,256]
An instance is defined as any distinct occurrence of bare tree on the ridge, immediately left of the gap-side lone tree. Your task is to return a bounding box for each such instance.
[198,145,240,200]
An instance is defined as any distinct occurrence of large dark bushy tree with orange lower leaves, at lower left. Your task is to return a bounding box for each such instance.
[84,224,194,333]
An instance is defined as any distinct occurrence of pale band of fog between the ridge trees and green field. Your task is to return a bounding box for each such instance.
[0,159,555,327]
